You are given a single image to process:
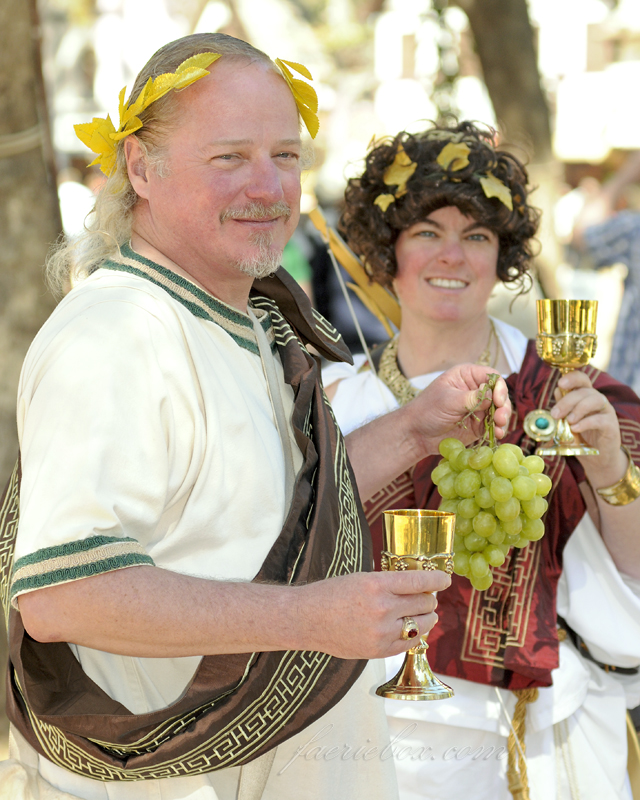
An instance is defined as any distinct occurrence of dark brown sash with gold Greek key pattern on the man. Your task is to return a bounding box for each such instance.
[0,270,372,781]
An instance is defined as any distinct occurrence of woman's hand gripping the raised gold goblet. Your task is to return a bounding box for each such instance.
[551,370,628,489]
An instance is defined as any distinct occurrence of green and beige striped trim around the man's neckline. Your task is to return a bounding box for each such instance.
[102,244,276,355]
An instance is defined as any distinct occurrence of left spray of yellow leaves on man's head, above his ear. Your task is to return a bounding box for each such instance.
[73,53,220,177]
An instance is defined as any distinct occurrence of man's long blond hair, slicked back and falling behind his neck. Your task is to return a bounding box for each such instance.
[45,33,278,295]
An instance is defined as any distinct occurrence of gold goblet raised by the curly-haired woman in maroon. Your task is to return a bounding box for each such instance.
[536,300,599,456]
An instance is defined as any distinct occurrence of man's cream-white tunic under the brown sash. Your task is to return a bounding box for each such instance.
[0,269,397,800]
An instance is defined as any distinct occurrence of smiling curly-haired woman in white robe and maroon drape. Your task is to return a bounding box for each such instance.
[325,122,640,800]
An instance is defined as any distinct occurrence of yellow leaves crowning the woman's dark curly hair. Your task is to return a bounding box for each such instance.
[373,130,524,213]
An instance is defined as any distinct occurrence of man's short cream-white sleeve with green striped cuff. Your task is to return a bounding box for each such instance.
[11,293,195,603]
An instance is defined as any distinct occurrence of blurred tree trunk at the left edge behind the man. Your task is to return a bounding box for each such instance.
[0,0,62,486]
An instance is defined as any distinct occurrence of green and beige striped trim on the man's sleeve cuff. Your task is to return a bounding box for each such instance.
[10,536,155,607]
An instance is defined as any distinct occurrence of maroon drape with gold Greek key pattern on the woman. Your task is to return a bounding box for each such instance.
[365,342,640,689]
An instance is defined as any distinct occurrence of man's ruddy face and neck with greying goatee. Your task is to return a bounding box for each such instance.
[134,56,301,286]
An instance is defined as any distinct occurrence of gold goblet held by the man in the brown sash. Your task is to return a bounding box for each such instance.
[376,509,456,700]
